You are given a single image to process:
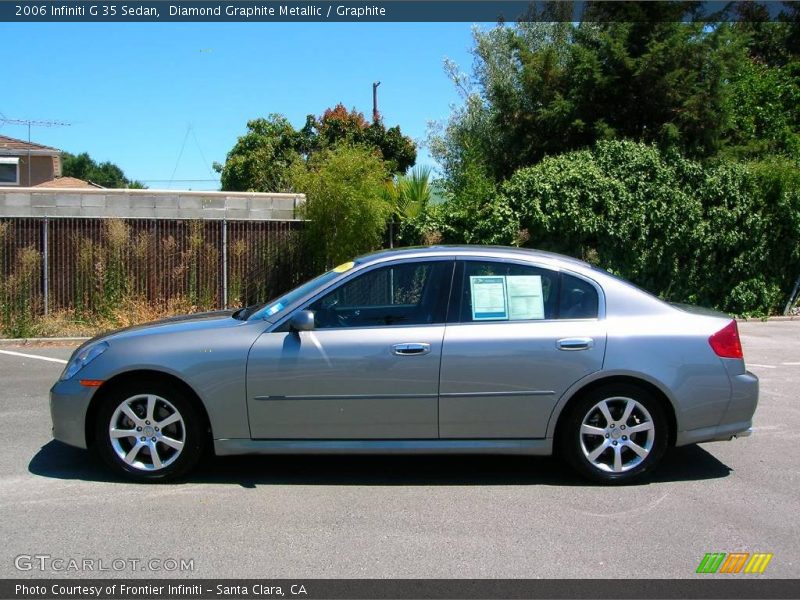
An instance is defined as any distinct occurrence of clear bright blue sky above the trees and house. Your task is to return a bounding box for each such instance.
[0,23,472,189]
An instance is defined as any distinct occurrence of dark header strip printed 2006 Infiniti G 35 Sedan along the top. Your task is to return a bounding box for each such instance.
[0,0,800,23]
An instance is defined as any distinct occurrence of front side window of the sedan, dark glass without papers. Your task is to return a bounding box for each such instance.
[308,261,453,329]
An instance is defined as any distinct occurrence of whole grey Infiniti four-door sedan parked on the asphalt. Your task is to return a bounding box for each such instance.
[50,246,758,483]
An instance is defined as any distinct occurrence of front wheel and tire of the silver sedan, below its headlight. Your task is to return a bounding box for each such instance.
[94,380,206,482]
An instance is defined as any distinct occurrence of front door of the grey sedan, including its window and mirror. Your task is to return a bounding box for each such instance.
[247,258,454,439]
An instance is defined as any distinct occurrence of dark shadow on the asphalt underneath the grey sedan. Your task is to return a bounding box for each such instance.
[28,440,731,488]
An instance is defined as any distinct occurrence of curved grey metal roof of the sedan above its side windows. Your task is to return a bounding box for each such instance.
[356,244,597,271]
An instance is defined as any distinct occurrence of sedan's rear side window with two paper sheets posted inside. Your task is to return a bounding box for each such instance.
[450,261,598,323]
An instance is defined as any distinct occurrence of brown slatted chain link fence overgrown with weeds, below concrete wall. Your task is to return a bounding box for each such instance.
[0,217,312,333]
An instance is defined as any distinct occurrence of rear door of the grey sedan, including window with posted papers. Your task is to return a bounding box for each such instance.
[439,259,606,438]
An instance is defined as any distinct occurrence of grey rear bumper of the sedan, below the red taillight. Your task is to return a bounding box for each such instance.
[675,371,758,446]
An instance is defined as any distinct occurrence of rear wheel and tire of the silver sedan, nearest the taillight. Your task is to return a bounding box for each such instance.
[557,384,669,484]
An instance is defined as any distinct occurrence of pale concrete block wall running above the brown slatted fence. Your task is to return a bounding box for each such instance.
[0,187,305,221]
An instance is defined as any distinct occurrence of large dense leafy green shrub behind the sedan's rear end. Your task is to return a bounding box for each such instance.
[495,141,800,314]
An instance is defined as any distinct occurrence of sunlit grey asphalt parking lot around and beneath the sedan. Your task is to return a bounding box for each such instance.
[0,320,800,578]
